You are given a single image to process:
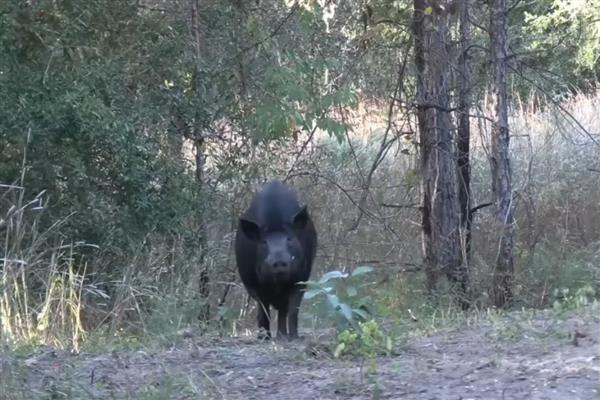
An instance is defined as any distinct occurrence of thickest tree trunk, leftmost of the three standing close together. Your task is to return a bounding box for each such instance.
[413,0,462,293]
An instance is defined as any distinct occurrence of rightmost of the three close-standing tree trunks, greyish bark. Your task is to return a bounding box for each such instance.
[489,0,514,307]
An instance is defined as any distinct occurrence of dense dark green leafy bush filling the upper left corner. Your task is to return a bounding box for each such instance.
[0,1,198,266]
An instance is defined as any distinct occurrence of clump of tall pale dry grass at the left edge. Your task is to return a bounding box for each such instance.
[0,185,95,350]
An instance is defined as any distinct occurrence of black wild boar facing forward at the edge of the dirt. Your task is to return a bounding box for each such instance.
[235,181,317,338]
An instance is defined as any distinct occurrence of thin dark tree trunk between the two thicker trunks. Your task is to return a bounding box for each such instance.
[457,0,473,308]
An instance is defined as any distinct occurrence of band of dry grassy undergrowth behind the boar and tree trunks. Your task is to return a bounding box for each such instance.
[0,95,600,351]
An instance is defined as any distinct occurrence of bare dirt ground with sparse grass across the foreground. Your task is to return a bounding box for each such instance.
[0,306,600,400]
